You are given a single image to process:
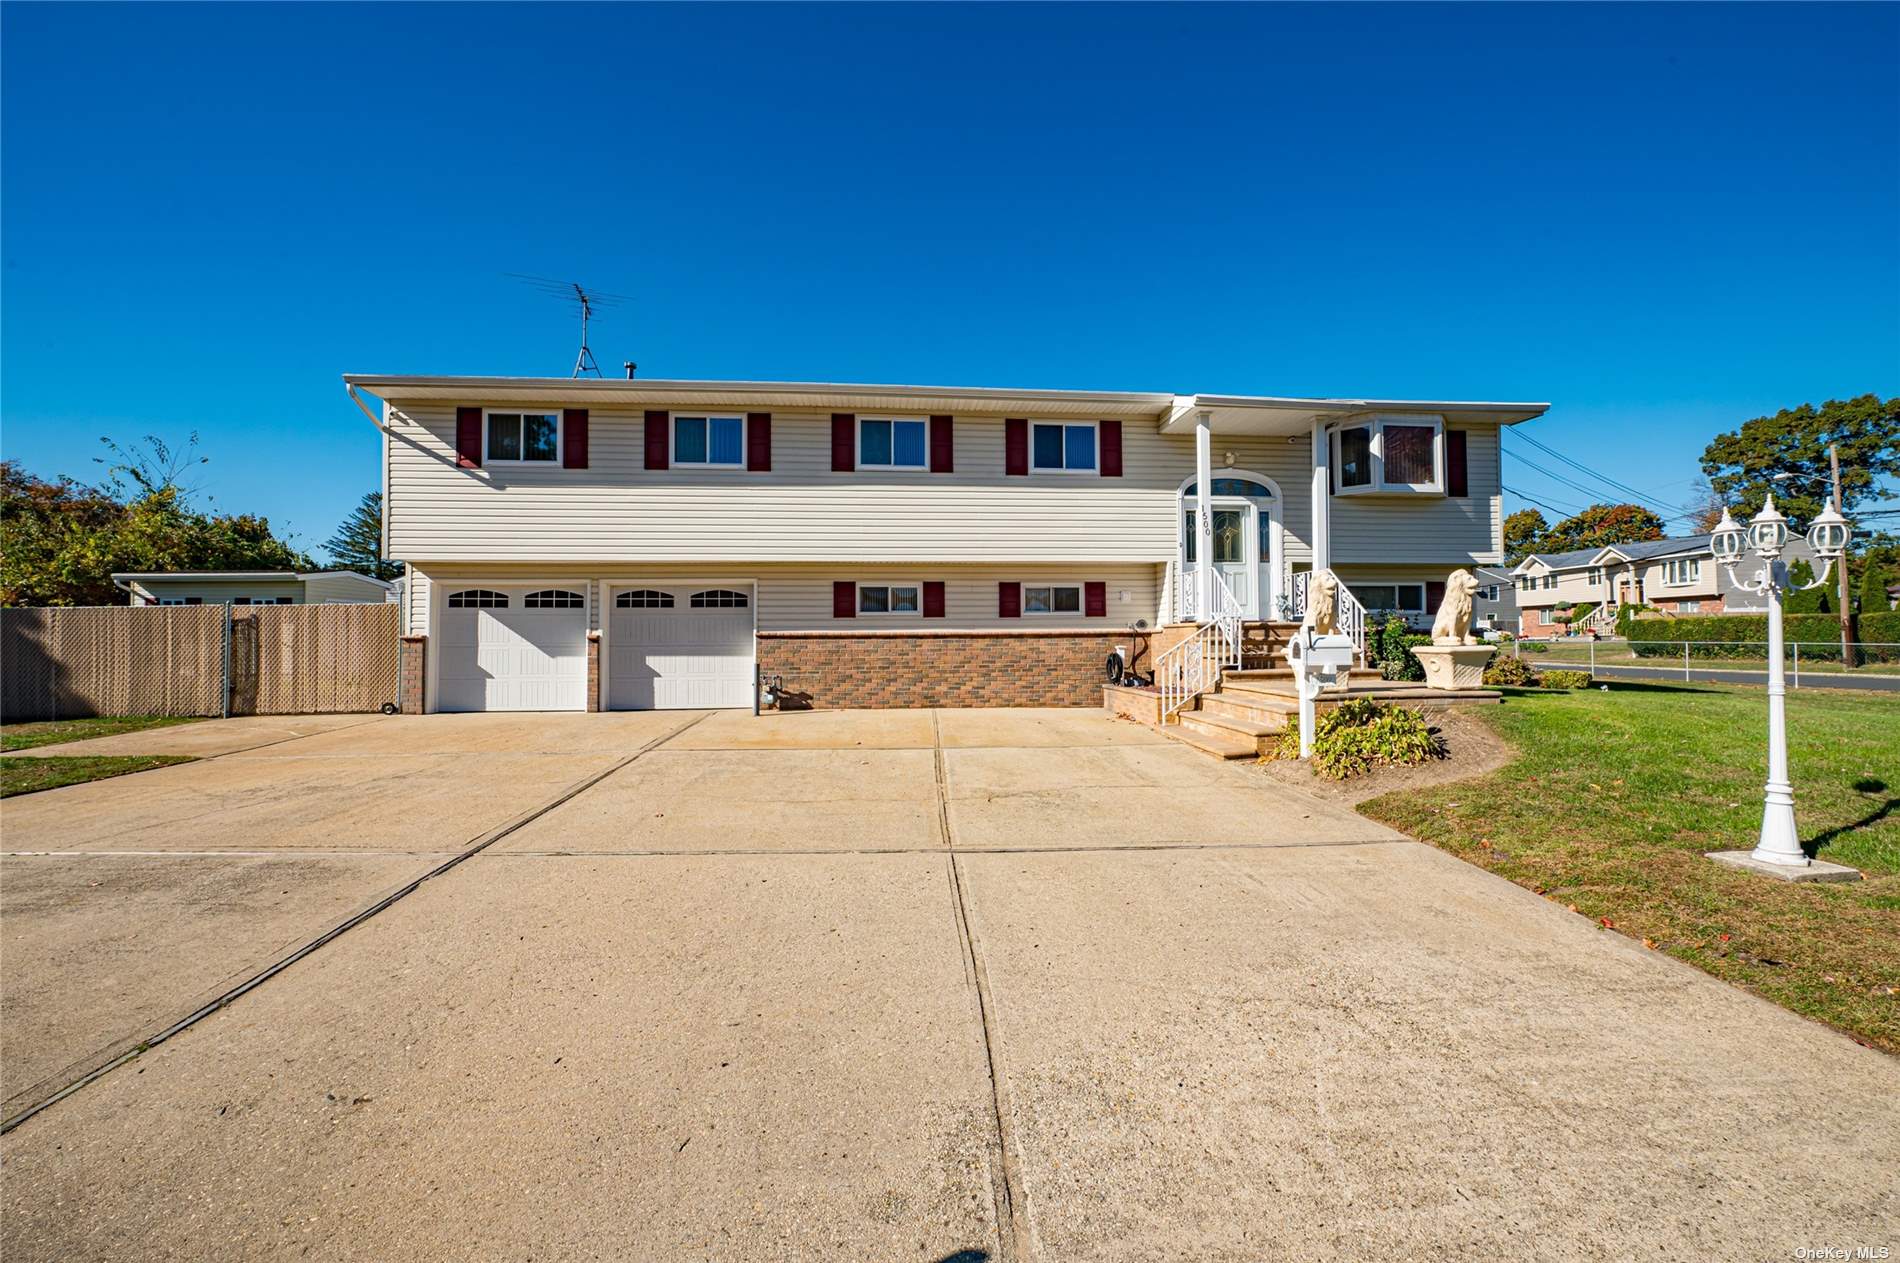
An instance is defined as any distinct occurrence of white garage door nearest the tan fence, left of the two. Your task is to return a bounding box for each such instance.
[435,583,587,710]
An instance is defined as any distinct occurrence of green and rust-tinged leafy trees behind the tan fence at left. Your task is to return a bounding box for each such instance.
[0,462,312,606]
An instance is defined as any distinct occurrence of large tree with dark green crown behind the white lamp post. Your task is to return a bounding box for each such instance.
[1702,395,1900,528]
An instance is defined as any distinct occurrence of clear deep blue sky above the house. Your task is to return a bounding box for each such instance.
[0,4,1900,547]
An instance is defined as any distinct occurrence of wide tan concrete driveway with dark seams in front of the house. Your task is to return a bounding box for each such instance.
[0,710,1900,1263]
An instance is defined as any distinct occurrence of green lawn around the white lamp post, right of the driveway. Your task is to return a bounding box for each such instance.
[1360,684,1900,1052]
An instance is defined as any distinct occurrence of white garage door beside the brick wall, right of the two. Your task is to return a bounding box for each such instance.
[606,585,752,710]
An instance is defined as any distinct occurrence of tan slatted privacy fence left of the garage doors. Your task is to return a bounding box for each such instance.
[0,604,397,722]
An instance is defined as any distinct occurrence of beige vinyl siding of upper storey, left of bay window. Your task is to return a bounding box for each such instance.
[390,399,1307,562]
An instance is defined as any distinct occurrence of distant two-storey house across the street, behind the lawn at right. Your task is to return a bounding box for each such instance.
[1511,536,1815,636]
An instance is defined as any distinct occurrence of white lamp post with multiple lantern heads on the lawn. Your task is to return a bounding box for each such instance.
[1708,496,1849,868]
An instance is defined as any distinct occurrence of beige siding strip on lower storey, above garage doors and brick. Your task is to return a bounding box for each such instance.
[409,562,1161,634]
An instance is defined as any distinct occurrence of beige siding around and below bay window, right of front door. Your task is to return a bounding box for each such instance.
[1330,425,1505,568]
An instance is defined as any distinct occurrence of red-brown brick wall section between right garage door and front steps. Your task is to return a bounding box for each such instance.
[758,631,1146,710]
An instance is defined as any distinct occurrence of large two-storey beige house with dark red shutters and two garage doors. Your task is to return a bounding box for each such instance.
[344,374,1547,710]
